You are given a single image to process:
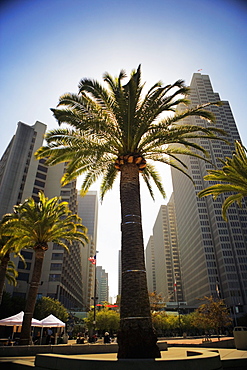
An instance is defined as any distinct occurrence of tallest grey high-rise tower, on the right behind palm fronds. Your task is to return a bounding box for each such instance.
[172,73,247,312]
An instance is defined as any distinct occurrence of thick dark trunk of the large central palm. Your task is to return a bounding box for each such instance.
[118,164,160,359]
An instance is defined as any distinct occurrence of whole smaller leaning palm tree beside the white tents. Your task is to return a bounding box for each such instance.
[3,193,88,345]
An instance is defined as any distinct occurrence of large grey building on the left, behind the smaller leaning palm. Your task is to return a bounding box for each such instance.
[0,121,83,309]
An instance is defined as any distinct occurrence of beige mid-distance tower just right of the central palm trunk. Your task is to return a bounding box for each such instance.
[146,194,183,302]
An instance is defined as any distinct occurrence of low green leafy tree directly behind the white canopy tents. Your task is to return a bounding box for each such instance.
[34,297,69,322]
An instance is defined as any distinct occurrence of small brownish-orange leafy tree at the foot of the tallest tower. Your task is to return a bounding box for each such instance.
[193,296,232,334]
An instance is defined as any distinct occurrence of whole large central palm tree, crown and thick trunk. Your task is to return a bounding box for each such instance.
[36,66,226,358]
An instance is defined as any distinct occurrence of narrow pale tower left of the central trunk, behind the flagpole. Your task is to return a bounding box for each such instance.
[78,191,98,311]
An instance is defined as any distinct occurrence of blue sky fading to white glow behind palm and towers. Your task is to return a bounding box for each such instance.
[0,0,247,296]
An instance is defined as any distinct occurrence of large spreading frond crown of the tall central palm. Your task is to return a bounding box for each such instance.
[36,66,223,199]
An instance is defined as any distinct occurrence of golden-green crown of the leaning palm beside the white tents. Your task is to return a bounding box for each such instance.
[2,192,87,253]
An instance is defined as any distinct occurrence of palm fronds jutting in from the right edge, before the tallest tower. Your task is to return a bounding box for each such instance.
[198,141,247,221]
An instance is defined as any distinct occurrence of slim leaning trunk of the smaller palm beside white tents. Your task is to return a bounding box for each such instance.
[20,248,45,345]
